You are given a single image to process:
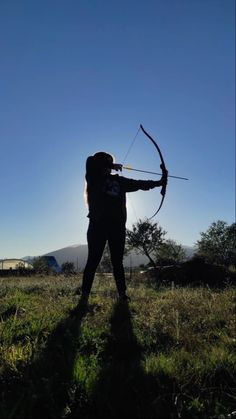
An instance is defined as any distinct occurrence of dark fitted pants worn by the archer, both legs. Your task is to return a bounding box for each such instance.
[82,219,126,294]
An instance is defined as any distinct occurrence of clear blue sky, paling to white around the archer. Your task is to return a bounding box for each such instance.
[0,0,235,258]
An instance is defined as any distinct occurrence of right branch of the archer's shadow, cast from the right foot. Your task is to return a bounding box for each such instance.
[70,303,178,419]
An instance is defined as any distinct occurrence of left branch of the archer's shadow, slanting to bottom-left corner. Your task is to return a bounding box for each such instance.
[0,304,86,418]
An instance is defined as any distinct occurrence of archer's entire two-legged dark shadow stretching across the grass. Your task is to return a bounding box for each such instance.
[0,303,181,419]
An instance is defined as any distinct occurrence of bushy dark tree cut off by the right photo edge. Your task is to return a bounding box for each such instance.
[196,220,236,266]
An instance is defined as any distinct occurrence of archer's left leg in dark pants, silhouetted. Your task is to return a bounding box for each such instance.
[82,221,106,295]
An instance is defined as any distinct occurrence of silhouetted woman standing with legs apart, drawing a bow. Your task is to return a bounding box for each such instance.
[82,152,163,301]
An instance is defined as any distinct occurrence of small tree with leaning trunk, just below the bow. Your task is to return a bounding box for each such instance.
[127,219,166,268]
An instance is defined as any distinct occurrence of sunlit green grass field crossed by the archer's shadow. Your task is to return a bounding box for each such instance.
[0,275,236,419]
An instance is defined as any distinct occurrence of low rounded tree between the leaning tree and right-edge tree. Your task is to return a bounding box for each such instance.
[155,240,186,265]
